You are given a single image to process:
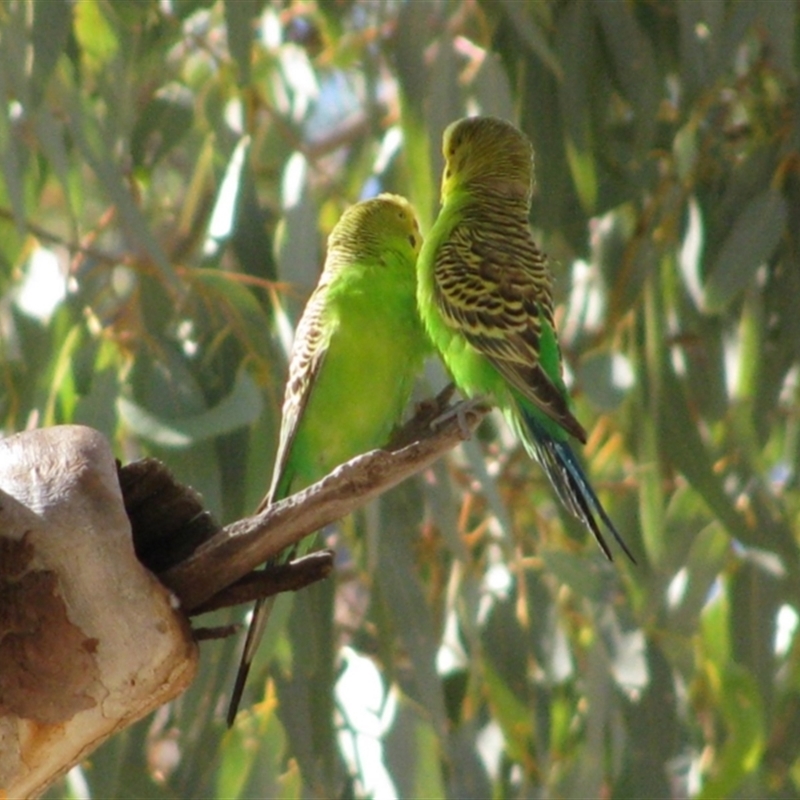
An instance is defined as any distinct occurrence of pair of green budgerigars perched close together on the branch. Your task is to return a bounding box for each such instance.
[228,117,633,724]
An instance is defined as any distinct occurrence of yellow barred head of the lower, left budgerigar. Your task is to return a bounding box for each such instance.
[328,193,422,265]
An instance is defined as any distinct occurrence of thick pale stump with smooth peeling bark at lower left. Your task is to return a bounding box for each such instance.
[0,426,197,797]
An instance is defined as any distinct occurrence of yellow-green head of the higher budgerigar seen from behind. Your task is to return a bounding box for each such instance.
[442,117,533,199]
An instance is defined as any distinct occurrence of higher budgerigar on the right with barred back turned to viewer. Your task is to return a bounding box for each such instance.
[417,117,634,561]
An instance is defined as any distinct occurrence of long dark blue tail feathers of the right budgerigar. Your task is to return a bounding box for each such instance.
[514,406,636,564]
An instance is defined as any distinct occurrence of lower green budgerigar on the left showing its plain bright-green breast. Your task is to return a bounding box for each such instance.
[228,194,431,725]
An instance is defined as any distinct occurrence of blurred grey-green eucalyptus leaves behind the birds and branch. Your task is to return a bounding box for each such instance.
[0,0,800,798]
